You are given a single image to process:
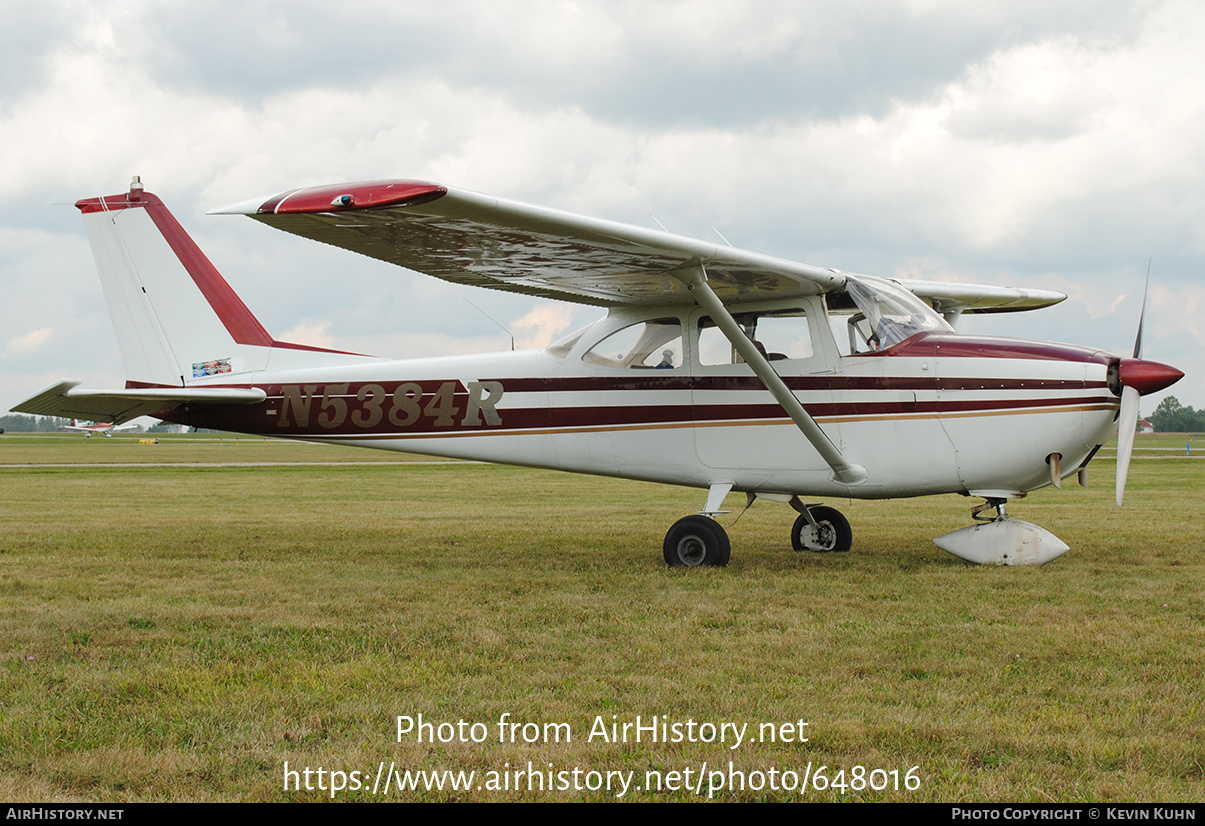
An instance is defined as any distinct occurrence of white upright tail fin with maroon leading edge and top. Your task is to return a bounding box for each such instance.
[76,177,365,387]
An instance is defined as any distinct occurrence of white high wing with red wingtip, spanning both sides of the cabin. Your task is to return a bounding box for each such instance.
[211,181,1065,312]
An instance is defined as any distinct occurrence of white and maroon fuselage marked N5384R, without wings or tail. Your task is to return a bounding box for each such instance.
[163,297,1119,499]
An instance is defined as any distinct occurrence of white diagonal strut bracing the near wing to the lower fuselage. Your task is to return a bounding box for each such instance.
[675,264,866,485]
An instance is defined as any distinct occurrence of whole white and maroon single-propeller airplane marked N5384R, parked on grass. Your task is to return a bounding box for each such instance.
[14,178,1182,566]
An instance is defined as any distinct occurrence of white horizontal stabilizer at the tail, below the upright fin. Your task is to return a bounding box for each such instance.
[12,379,268,424]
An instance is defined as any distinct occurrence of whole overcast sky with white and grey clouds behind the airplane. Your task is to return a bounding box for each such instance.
[0,0,1205,414]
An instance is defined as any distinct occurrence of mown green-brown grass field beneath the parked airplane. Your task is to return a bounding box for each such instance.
[0,434,1205,802]
